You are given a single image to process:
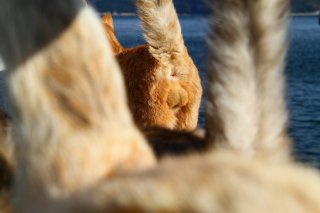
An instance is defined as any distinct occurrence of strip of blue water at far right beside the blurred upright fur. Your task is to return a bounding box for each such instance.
[286,17,320,167]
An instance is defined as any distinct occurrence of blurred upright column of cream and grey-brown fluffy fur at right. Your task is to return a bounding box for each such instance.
[207,0,290,160]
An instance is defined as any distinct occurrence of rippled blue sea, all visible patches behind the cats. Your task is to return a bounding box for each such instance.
[0,16,320,168]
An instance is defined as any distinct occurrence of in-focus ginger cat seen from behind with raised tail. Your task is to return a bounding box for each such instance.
[102,0,202,131]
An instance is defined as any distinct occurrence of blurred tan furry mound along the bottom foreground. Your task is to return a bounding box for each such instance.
[69,152,320,213]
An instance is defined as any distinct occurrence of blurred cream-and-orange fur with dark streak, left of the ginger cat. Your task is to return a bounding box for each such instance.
[2,4,155,212]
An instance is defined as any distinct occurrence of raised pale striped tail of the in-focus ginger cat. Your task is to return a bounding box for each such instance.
[136,0,185,58]
